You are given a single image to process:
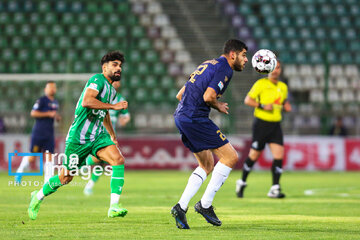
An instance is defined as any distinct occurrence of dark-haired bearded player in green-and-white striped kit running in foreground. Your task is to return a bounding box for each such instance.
[28,51,128,220]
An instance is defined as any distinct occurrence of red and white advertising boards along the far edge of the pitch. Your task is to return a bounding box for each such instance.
[0,135,360,171]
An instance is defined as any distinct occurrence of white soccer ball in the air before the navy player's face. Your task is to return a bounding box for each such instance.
[251,49,277,74]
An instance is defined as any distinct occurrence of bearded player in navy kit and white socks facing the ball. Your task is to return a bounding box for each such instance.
[171,39,248,229]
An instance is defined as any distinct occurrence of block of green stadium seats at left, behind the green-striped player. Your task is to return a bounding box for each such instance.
[0,0,189,132]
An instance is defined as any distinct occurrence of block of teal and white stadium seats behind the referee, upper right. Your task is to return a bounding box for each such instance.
[217,0,360,134]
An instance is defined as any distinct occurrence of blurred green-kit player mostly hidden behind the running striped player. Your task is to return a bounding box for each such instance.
[84,81,130,196]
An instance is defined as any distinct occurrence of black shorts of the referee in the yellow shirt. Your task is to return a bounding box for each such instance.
[251,118,284,151]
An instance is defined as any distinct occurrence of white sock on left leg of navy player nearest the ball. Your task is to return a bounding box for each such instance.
[179,167,207,210]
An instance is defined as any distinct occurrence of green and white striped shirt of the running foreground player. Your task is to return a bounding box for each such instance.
[66,74,116,144]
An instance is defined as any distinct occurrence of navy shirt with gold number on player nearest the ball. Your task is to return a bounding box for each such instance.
[174,57,233,120]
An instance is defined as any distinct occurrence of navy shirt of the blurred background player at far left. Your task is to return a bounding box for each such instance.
[32,96,59,139]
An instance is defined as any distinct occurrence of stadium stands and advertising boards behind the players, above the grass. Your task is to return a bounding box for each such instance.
[0,0,360,170]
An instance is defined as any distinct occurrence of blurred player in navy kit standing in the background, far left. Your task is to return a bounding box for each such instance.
[15,81,61,183]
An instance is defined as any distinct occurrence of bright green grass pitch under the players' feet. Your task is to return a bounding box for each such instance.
[0,171,360,240]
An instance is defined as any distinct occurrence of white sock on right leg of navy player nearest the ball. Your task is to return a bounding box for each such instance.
[201,162,232,208]
